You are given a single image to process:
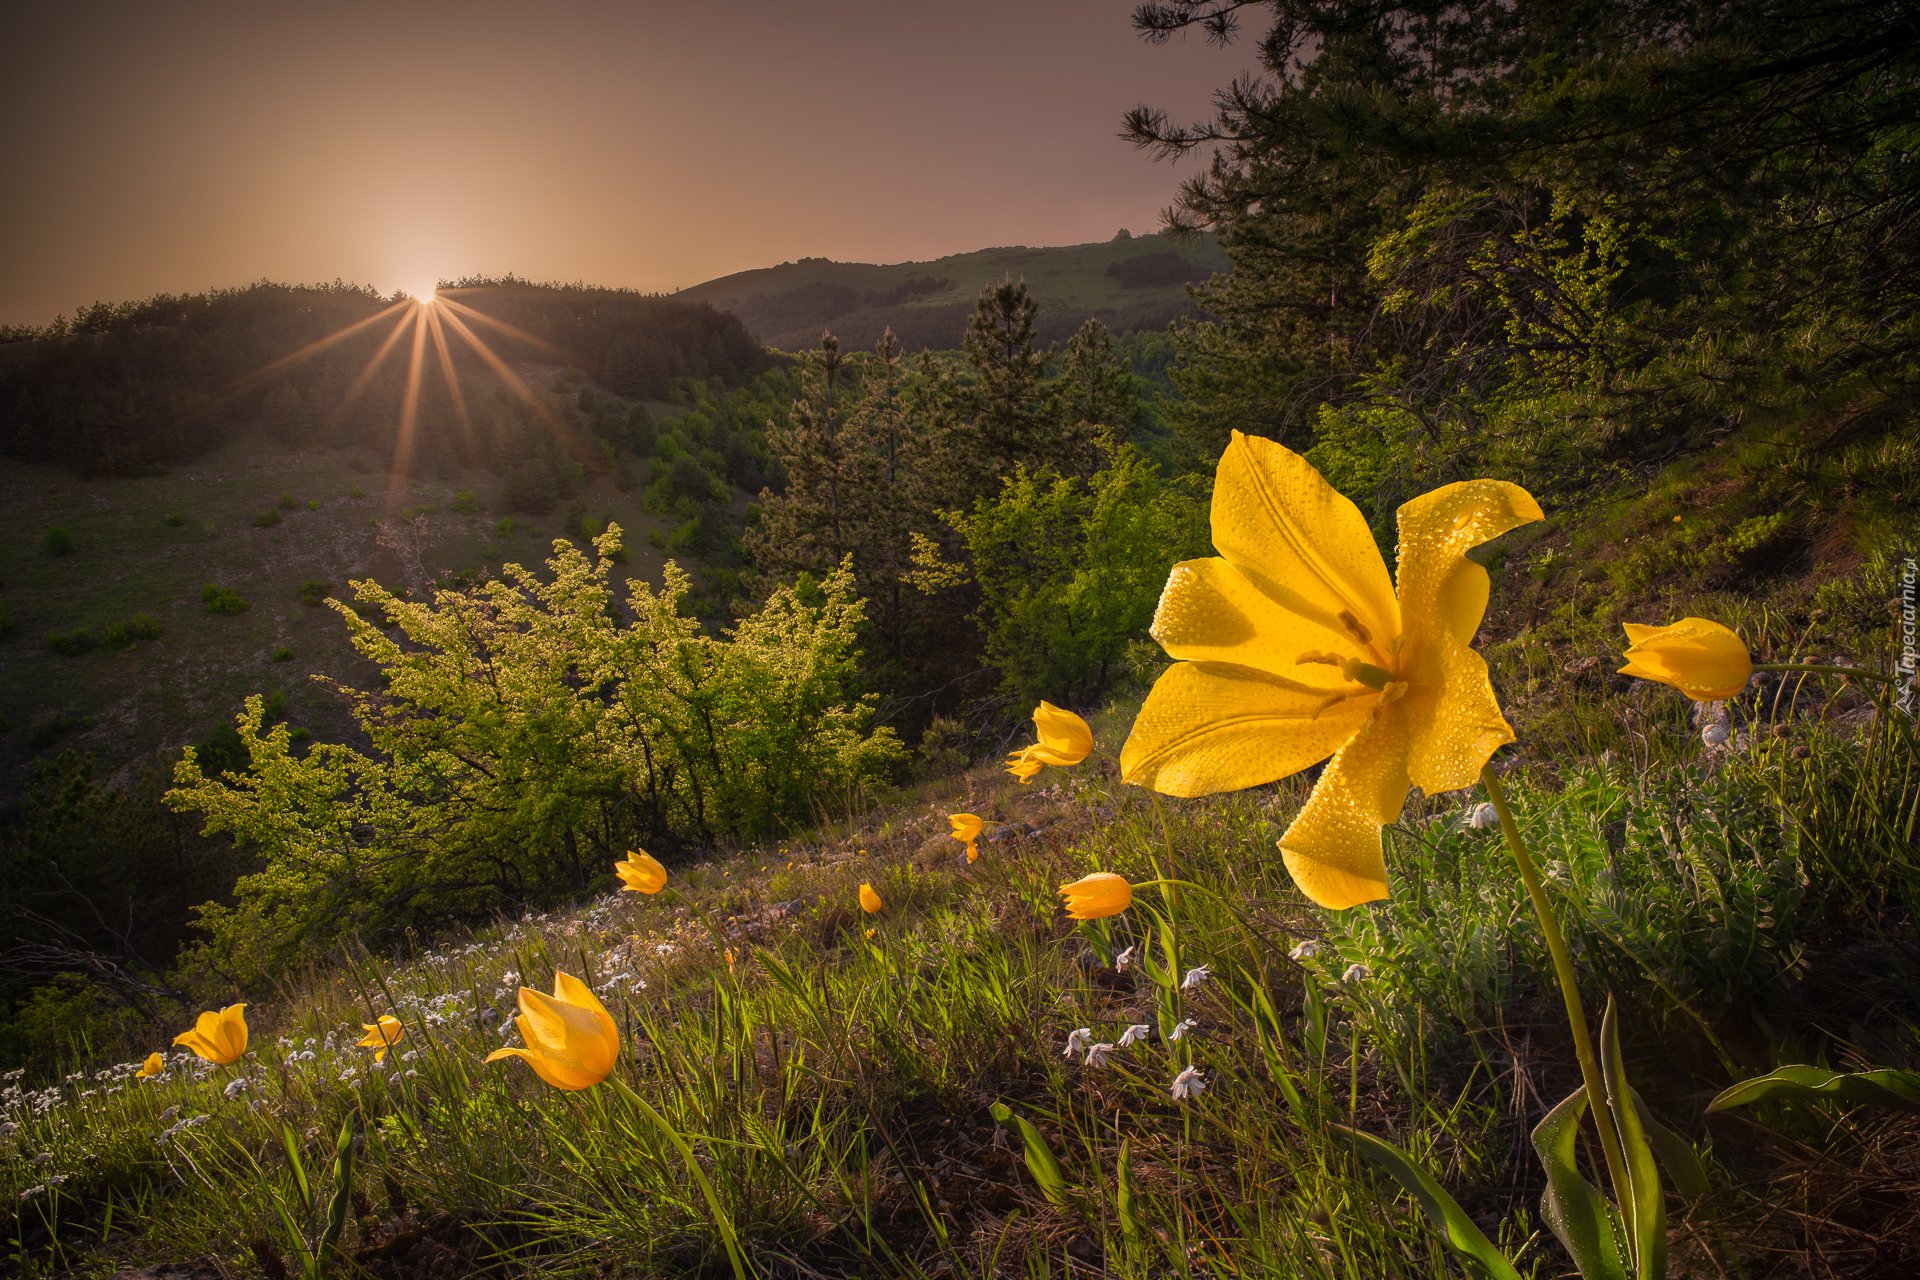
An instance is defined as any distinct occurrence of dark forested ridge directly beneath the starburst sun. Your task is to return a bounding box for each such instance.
[0,278,766,476]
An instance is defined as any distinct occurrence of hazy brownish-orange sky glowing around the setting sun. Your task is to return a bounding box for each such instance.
[0,0,1254,324]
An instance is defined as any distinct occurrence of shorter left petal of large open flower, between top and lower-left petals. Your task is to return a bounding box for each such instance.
[1152,557,1390,671]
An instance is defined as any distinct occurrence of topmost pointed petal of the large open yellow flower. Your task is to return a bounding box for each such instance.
[1213,432,1400,666]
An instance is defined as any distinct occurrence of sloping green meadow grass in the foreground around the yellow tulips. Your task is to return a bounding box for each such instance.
[0,671,1920,1278]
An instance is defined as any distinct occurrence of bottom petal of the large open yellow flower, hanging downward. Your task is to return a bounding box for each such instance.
[1279,704,1409,912]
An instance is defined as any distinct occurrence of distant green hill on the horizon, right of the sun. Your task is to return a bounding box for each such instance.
[674,236,1229,351]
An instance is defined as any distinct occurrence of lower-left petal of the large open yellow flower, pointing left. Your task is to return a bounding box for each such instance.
[1119,662,1379,796]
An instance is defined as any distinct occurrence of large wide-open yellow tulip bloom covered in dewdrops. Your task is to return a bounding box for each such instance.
[1119,432,1542,908]
